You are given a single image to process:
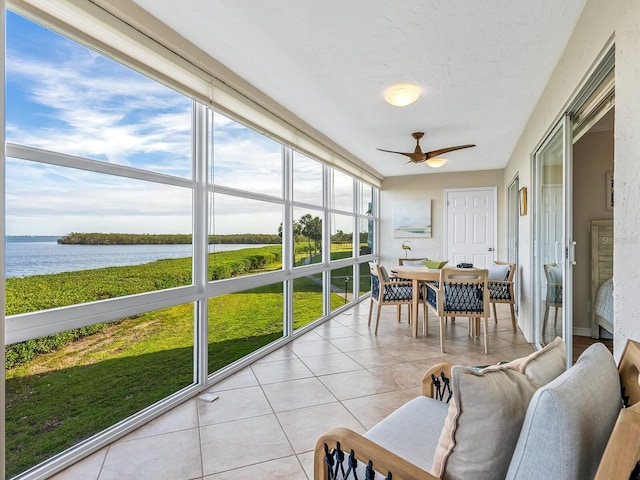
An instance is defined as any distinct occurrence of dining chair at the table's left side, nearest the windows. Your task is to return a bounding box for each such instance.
[368,262,418,335]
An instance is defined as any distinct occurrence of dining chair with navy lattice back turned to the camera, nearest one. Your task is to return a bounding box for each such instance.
[425,267,490,353]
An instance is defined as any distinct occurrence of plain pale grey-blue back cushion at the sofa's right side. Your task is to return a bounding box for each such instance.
[507,343,622,480]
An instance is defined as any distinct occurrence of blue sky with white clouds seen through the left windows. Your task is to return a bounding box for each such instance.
[5,11,344,235]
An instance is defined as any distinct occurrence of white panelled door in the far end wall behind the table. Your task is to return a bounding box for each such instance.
[445,187,497,268]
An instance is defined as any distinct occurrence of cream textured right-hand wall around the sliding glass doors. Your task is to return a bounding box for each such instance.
[504,0,640,357]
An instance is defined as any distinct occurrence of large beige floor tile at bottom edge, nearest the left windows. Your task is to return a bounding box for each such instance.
[100,428,202,480]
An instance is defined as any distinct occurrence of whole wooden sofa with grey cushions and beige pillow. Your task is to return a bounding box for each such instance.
[315,339,640,480]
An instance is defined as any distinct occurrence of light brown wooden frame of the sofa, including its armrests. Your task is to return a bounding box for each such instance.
[314,340,640,480]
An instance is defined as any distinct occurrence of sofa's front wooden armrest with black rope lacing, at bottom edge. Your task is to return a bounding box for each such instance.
[313,428,437,480]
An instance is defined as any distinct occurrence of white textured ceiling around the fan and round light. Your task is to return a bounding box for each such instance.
[130,0,585,176]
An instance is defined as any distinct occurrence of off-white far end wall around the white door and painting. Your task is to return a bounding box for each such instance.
[380,171,507,266]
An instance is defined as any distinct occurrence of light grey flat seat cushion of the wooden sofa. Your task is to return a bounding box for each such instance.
[358,396,448,470]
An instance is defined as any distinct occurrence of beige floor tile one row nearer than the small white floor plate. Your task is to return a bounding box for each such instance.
[200,415,293,475]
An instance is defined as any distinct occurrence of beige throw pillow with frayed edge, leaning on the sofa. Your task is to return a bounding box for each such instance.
[430,339,566,480]
